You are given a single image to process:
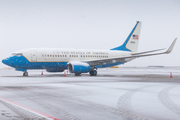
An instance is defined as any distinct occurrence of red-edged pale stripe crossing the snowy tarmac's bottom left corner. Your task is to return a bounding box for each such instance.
[0,97,60,120]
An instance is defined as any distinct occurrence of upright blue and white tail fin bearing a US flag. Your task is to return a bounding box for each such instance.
[111,21,142,52]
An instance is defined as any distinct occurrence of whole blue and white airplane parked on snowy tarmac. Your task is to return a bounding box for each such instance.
[2,21,177,76]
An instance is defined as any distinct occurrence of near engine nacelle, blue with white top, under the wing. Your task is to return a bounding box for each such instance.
[68,62,91,73]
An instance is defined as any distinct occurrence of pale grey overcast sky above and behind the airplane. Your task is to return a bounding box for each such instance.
[0,0,180,67]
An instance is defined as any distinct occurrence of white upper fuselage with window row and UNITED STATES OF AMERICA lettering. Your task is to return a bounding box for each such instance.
[13,48,131,62]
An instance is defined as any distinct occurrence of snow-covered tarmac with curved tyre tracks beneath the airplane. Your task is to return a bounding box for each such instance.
[0,67,180,120]
